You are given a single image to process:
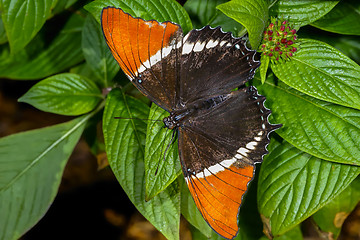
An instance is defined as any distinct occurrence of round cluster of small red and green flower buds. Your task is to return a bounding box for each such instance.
[260,18,297,61]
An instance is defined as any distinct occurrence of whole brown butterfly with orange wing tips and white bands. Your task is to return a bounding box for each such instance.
[101,7,280,239]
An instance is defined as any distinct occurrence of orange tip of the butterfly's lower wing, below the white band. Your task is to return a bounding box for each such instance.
[187,165,254,239]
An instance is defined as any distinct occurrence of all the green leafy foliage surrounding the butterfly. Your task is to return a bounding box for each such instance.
[0,0,360,240]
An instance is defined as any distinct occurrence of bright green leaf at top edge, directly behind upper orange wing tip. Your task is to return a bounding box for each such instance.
[85,0,192,33]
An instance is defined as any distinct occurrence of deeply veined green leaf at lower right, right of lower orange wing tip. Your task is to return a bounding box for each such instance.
[258,138,360,236]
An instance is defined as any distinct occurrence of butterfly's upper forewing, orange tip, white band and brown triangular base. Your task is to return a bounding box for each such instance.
[101,7,183,111]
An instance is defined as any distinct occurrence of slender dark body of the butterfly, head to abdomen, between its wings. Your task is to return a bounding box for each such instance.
[163,94,229,129]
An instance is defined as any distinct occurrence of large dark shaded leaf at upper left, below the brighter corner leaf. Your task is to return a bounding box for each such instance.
[0,14,84,80]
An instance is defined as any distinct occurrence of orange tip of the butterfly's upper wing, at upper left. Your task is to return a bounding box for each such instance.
[101,7,181,79]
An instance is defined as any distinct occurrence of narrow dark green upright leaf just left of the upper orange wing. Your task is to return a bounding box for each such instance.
[82,16,120,87]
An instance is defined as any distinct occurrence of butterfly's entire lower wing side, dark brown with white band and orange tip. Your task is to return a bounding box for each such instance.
[179,87,279,239]
